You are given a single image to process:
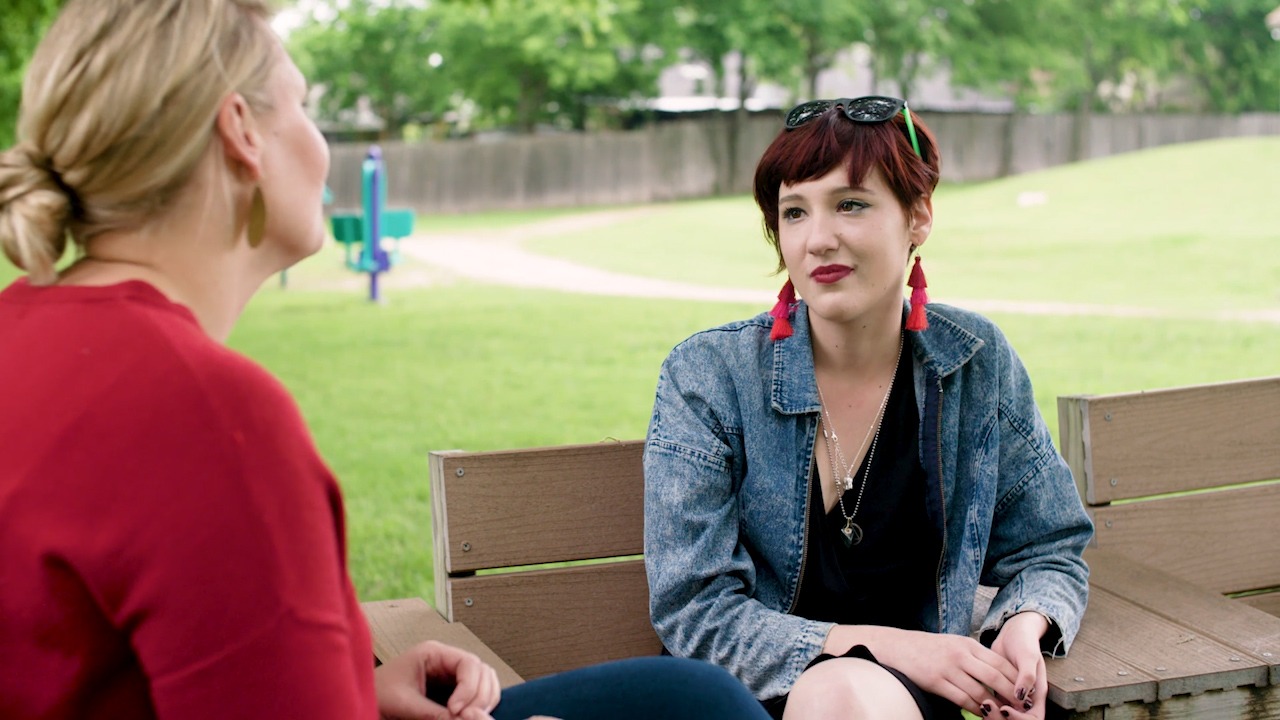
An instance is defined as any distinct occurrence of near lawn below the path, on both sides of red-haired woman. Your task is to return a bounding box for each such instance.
[232,284,1280,600]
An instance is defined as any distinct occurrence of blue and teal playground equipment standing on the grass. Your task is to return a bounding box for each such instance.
[330,145,413,302]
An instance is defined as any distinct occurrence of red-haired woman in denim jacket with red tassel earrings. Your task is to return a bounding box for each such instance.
[644,96,1092,720]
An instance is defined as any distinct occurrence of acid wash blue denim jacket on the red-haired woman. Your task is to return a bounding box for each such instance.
[644,302,1093,700]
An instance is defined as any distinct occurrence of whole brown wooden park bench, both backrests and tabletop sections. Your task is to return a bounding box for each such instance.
[366,378,1280,720]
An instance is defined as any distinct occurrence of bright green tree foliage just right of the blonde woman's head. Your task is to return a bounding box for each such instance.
[289,0,660,133]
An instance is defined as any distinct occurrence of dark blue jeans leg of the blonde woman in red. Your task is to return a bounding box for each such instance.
[493,657,769,720]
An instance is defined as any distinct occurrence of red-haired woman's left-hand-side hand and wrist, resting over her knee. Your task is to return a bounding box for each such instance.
[860,625,1018,716]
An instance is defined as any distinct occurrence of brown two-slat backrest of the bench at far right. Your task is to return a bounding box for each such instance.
[1059,377,1280,607]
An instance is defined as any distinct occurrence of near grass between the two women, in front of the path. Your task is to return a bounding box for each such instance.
[232,286,754,598]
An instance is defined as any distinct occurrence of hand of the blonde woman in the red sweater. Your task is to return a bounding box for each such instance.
[374,641,502,720]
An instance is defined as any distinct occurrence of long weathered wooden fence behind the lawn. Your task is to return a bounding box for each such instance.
[329,113,1280,214]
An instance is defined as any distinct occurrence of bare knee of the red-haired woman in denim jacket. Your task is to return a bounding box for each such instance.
[783,657,920,720]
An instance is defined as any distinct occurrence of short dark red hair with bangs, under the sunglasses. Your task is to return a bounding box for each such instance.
[755,106,941,272]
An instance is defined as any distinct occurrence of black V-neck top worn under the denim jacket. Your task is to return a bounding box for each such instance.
[795,336,942,630]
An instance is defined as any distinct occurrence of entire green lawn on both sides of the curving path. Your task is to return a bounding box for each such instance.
[0,133,1280,600]
